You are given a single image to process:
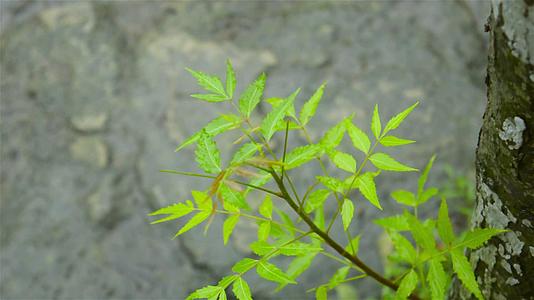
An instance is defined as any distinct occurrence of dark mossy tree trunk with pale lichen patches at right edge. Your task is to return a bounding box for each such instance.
[451,0,534,300]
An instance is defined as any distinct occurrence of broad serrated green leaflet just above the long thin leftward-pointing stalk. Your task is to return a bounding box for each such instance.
[195,129,221,174]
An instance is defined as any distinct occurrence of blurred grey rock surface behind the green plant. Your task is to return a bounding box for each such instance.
[0,0,489,299]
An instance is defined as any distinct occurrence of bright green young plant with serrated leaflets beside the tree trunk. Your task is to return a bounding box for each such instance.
[150,61,503,300]
